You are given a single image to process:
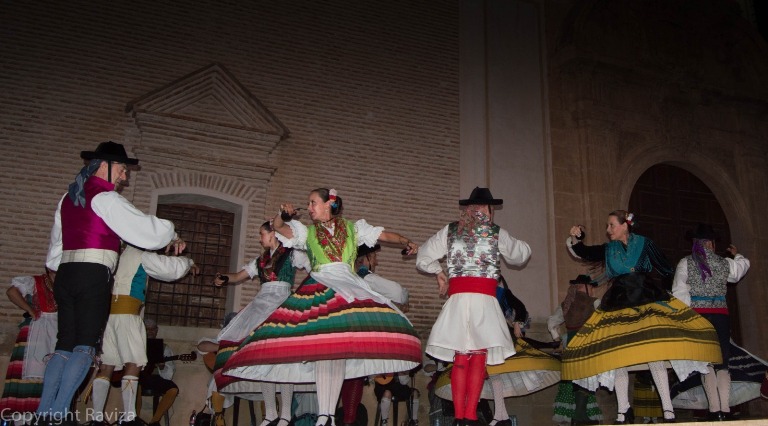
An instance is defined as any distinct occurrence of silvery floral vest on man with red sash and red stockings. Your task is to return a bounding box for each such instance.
[446,222,501,279]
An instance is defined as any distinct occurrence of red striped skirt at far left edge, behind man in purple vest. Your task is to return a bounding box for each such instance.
[0,319,43,415]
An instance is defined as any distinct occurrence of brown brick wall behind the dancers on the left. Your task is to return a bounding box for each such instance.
[0,1,459,338]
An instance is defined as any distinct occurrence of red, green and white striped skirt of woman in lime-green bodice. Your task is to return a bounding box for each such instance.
[223,263,421,383]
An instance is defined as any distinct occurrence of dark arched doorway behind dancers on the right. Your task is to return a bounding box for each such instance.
[629,164,741,343]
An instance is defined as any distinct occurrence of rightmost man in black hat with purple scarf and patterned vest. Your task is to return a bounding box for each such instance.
[672,223,749,420]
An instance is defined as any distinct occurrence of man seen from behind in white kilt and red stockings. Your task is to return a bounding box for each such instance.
[416,187,531,426]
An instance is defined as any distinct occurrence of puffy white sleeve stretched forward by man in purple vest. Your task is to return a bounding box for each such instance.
[91,191,178,250]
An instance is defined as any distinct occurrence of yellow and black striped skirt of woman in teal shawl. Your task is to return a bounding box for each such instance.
[562,297,722,391]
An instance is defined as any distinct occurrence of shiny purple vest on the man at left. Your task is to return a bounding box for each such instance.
[61,176,120,253]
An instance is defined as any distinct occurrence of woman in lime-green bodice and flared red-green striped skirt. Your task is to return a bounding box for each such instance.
[216,188,421,425]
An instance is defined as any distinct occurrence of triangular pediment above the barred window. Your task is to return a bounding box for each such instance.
[126,63,288,139]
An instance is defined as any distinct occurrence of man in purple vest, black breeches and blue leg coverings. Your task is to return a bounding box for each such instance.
[37,141,185,424]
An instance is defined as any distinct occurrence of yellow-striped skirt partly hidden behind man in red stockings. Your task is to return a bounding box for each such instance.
[435,339,560,401]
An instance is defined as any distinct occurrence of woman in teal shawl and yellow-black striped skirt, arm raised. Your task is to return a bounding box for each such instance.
[562,210,721,424]
